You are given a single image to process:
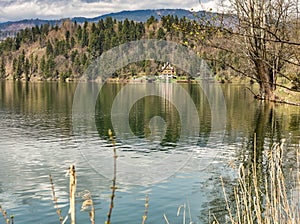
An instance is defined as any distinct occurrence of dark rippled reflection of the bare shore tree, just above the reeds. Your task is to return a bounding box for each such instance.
[242,102,300,172]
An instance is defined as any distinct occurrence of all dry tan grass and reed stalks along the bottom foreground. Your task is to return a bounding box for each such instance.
[0,134,300,224]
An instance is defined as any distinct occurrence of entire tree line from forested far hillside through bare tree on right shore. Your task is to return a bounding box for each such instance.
[0,5,300,100]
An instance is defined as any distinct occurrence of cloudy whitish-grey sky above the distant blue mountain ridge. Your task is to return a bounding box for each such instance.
[0,0,217,22]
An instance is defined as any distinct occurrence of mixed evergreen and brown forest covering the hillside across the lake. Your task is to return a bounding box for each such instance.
[0,11,300,94]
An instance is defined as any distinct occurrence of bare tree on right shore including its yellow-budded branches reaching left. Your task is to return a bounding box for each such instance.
[192,0,300,100]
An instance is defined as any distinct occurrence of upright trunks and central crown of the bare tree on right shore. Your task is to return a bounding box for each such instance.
[230,0,300,100]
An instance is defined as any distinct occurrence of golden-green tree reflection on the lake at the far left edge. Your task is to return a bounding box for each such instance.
[0,81,76,135]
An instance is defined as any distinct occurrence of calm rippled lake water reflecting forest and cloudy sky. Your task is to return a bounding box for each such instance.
[0,82,300,224]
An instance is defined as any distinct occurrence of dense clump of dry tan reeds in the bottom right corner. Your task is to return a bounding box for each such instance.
[221,138,300,224]
